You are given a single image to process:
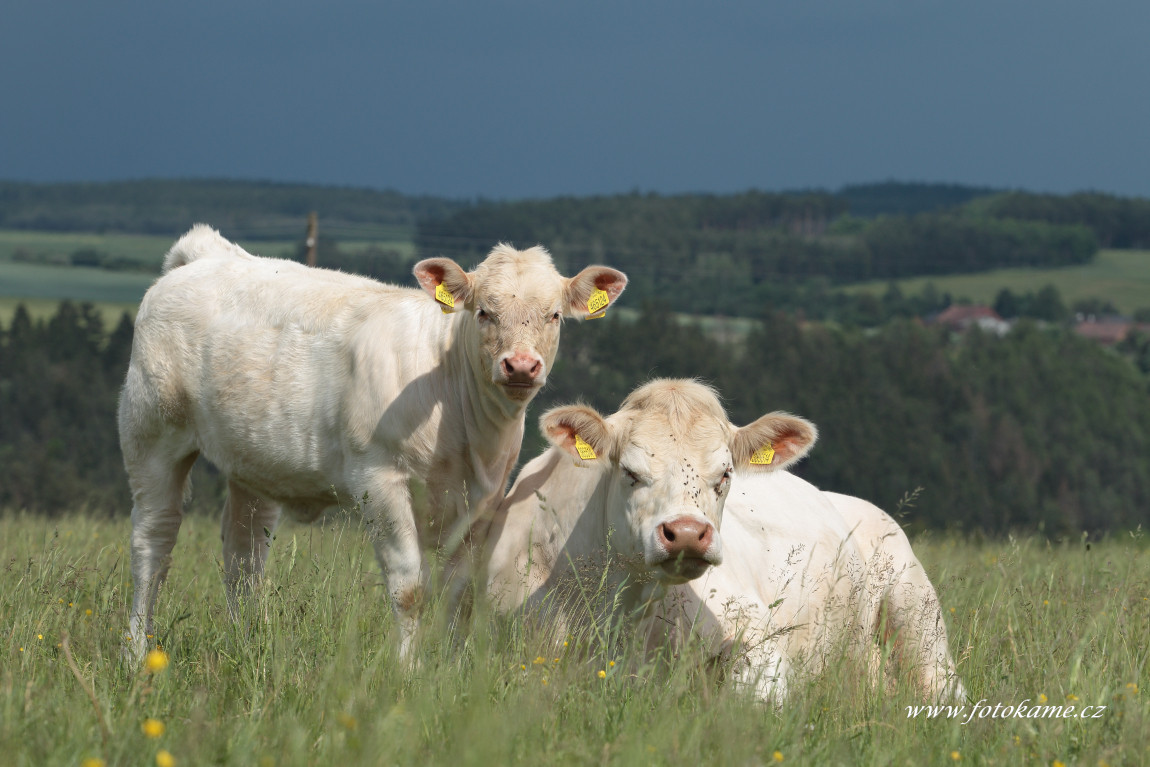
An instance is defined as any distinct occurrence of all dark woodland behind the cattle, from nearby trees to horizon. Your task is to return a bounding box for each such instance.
[0,181,1150,535]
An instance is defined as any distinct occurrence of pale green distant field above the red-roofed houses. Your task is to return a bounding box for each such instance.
[844,251,1150,312]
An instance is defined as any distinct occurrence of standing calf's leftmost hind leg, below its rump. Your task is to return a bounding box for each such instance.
[127,450,197,664]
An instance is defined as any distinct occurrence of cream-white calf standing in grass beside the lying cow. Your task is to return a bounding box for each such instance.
[120,225,627,658]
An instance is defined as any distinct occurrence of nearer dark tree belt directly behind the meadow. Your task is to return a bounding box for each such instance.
[0,301,1150,535]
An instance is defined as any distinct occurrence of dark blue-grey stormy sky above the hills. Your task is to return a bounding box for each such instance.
[0,0,1150,198]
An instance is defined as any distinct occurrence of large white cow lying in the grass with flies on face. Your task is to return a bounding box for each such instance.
[486,381,963,700]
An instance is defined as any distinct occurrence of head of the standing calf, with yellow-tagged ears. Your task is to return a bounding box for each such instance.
[414,245,627,404]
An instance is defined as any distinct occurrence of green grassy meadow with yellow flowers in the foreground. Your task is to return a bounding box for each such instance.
[0,514,1150,767]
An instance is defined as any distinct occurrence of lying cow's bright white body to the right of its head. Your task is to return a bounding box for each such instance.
[641,471,965,700]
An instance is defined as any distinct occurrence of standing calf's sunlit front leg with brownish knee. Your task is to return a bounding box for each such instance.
[362,475,424,658]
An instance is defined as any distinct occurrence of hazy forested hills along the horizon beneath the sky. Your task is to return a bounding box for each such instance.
[0,181,1150,322]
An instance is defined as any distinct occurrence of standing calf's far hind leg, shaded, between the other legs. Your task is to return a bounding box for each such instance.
[220,481,281,618]
